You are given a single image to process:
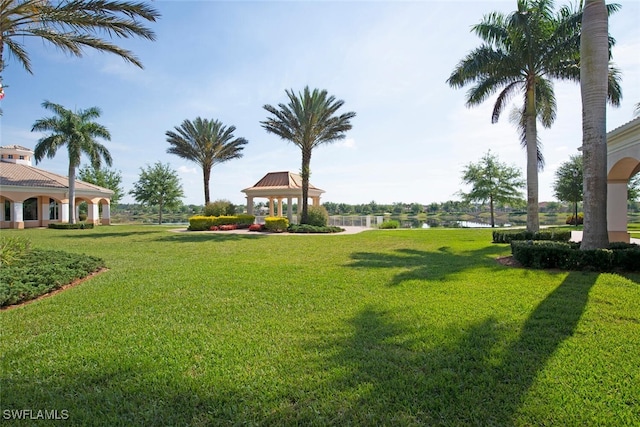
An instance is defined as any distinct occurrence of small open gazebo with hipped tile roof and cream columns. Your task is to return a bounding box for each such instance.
[242,172,325,223]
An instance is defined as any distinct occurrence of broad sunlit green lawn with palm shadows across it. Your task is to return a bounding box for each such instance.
[0,226,640,426]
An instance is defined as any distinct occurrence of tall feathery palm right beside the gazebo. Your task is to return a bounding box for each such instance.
[260,86,356,224]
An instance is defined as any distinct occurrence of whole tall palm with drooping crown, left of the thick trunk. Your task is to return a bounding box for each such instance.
[447,0,621,232]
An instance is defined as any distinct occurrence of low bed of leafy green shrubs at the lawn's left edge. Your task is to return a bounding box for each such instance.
[0,249,105,306]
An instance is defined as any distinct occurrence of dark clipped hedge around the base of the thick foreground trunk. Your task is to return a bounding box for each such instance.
[511,240,640,272]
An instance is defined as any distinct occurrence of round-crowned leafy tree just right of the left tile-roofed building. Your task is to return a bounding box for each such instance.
[129,162,184,224]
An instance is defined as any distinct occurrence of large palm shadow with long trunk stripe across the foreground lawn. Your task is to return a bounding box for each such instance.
[304,273,597,425]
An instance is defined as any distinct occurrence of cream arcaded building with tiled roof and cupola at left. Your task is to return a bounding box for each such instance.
[0,145,113,228]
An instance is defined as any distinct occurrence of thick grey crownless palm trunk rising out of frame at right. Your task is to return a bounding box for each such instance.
[580,0,609,250]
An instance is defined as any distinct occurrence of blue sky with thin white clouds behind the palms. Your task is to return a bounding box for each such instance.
[0,0,640,204]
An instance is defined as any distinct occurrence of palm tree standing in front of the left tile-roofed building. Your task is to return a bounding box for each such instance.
[31,101,112,224]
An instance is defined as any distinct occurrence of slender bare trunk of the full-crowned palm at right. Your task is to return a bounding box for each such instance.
[524,82,540,233]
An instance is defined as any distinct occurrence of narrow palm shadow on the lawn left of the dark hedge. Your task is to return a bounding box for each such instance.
[349,245,504,286]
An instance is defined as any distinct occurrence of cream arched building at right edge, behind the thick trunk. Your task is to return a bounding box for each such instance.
[607,117,640,243]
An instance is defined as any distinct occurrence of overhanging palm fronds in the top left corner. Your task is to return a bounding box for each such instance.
[0,0,160,90]
